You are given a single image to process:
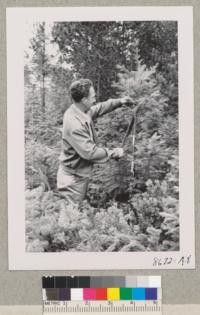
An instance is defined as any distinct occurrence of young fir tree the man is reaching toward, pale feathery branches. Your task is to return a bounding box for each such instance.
[90,41,171,207]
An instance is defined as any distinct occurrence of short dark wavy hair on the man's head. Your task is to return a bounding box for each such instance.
[70,79,93,102]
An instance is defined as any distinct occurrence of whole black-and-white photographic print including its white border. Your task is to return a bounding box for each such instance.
[8,7,194,269]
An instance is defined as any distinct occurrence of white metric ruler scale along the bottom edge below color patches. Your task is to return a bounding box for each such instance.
[43,301,162,315]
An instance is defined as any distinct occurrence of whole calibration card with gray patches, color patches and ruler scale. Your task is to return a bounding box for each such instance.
[42,276,162,315]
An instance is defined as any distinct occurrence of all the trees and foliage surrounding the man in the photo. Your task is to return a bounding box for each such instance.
[24,21,179,252]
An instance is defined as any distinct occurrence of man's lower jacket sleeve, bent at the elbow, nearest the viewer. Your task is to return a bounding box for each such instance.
[64,124,107,161]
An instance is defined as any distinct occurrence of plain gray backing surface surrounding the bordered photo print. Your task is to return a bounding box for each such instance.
[0,0,200,305]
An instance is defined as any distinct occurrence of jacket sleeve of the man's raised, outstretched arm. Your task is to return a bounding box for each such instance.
[89,98,122,119]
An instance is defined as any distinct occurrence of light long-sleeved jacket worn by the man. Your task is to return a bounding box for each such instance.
[59,99,122,177]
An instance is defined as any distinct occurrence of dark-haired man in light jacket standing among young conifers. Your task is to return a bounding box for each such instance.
[57,79,133,204]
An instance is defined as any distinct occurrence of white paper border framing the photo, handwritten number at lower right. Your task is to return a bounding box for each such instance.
[7,6,195,270]
